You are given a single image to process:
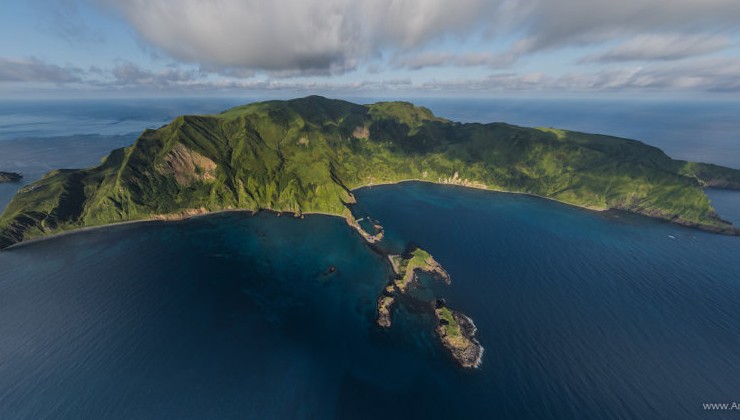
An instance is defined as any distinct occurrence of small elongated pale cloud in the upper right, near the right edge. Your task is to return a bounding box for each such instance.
[582,34,732,63]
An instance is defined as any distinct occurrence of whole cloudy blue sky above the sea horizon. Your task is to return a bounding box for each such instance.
[0,0,740,100]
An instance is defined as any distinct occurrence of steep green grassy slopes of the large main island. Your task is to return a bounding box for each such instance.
[0,97,740,248]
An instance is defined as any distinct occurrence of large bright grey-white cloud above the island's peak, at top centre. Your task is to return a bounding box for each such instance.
[98,0,503,73]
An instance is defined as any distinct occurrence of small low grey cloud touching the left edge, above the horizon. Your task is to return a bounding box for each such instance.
[0,57,84,84]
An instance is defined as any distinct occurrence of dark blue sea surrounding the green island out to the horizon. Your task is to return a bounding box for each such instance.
[0,98,740,420]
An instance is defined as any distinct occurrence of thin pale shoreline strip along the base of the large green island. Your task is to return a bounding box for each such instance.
[0,178,740,252]
